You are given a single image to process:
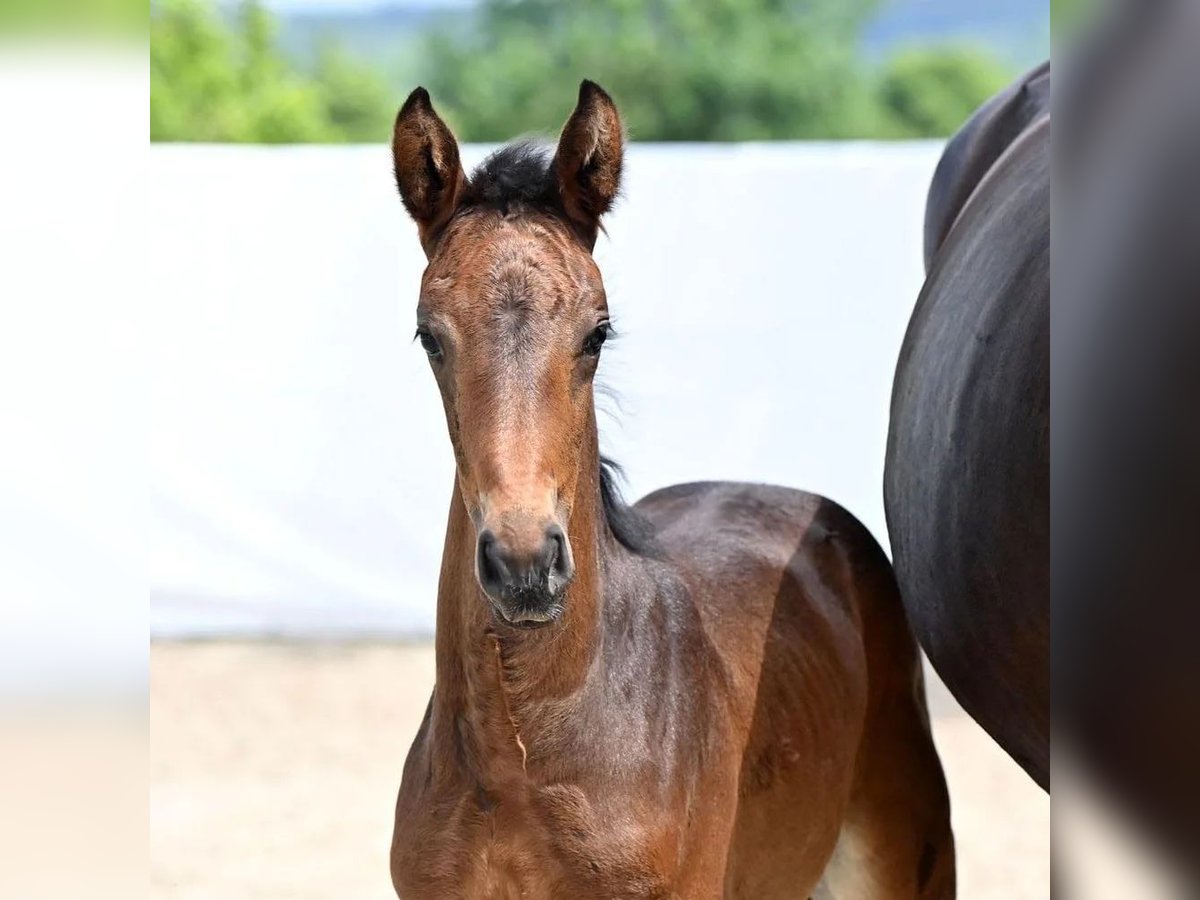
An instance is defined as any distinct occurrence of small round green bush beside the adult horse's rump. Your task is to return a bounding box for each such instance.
[878,47,1013,138]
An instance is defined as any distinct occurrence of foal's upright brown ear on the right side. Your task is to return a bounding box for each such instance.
[554,80,625,246]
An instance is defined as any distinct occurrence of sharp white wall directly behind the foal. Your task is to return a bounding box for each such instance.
[145,143,940,636]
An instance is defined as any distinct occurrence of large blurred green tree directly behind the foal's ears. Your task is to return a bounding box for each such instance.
[427,0,877,140]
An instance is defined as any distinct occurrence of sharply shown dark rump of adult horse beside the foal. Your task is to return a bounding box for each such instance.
[883,65,1050,787]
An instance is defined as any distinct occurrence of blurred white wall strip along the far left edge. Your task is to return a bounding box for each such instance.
[0,51,150,696]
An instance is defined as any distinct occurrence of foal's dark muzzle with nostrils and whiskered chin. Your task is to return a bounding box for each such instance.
[475,523,575,625]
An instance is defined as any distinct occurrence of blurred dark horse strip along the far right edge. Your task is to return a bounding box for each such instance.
[1051,1,1200,892]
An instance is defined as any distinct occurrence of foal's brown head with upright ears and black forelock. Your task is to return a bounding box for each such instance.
[392,82,624,625]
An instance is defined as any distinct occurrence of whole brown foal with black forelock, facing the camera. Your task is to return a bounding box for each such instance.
[391,82,954,900]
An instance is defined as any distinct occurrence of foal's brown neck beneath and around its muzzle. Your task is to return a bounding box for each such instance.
[434,438,612,755]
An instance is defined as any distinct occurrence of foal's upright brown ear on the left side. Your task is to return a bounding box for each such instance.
[391,88,467,254]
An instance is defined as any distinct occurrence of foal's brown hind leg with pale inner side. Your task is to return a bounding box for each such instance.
[816,532,955,900]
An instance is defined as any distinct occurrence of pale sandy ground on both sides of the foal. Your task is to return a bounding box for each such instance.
[150,643,1050,900]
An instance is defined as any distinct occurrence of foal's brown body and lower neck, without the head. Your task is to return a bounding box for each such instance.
[392,475,954,900]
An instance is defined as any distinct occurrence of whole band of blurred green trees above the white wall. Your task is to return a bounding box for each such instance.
[150,0,1014,143]
